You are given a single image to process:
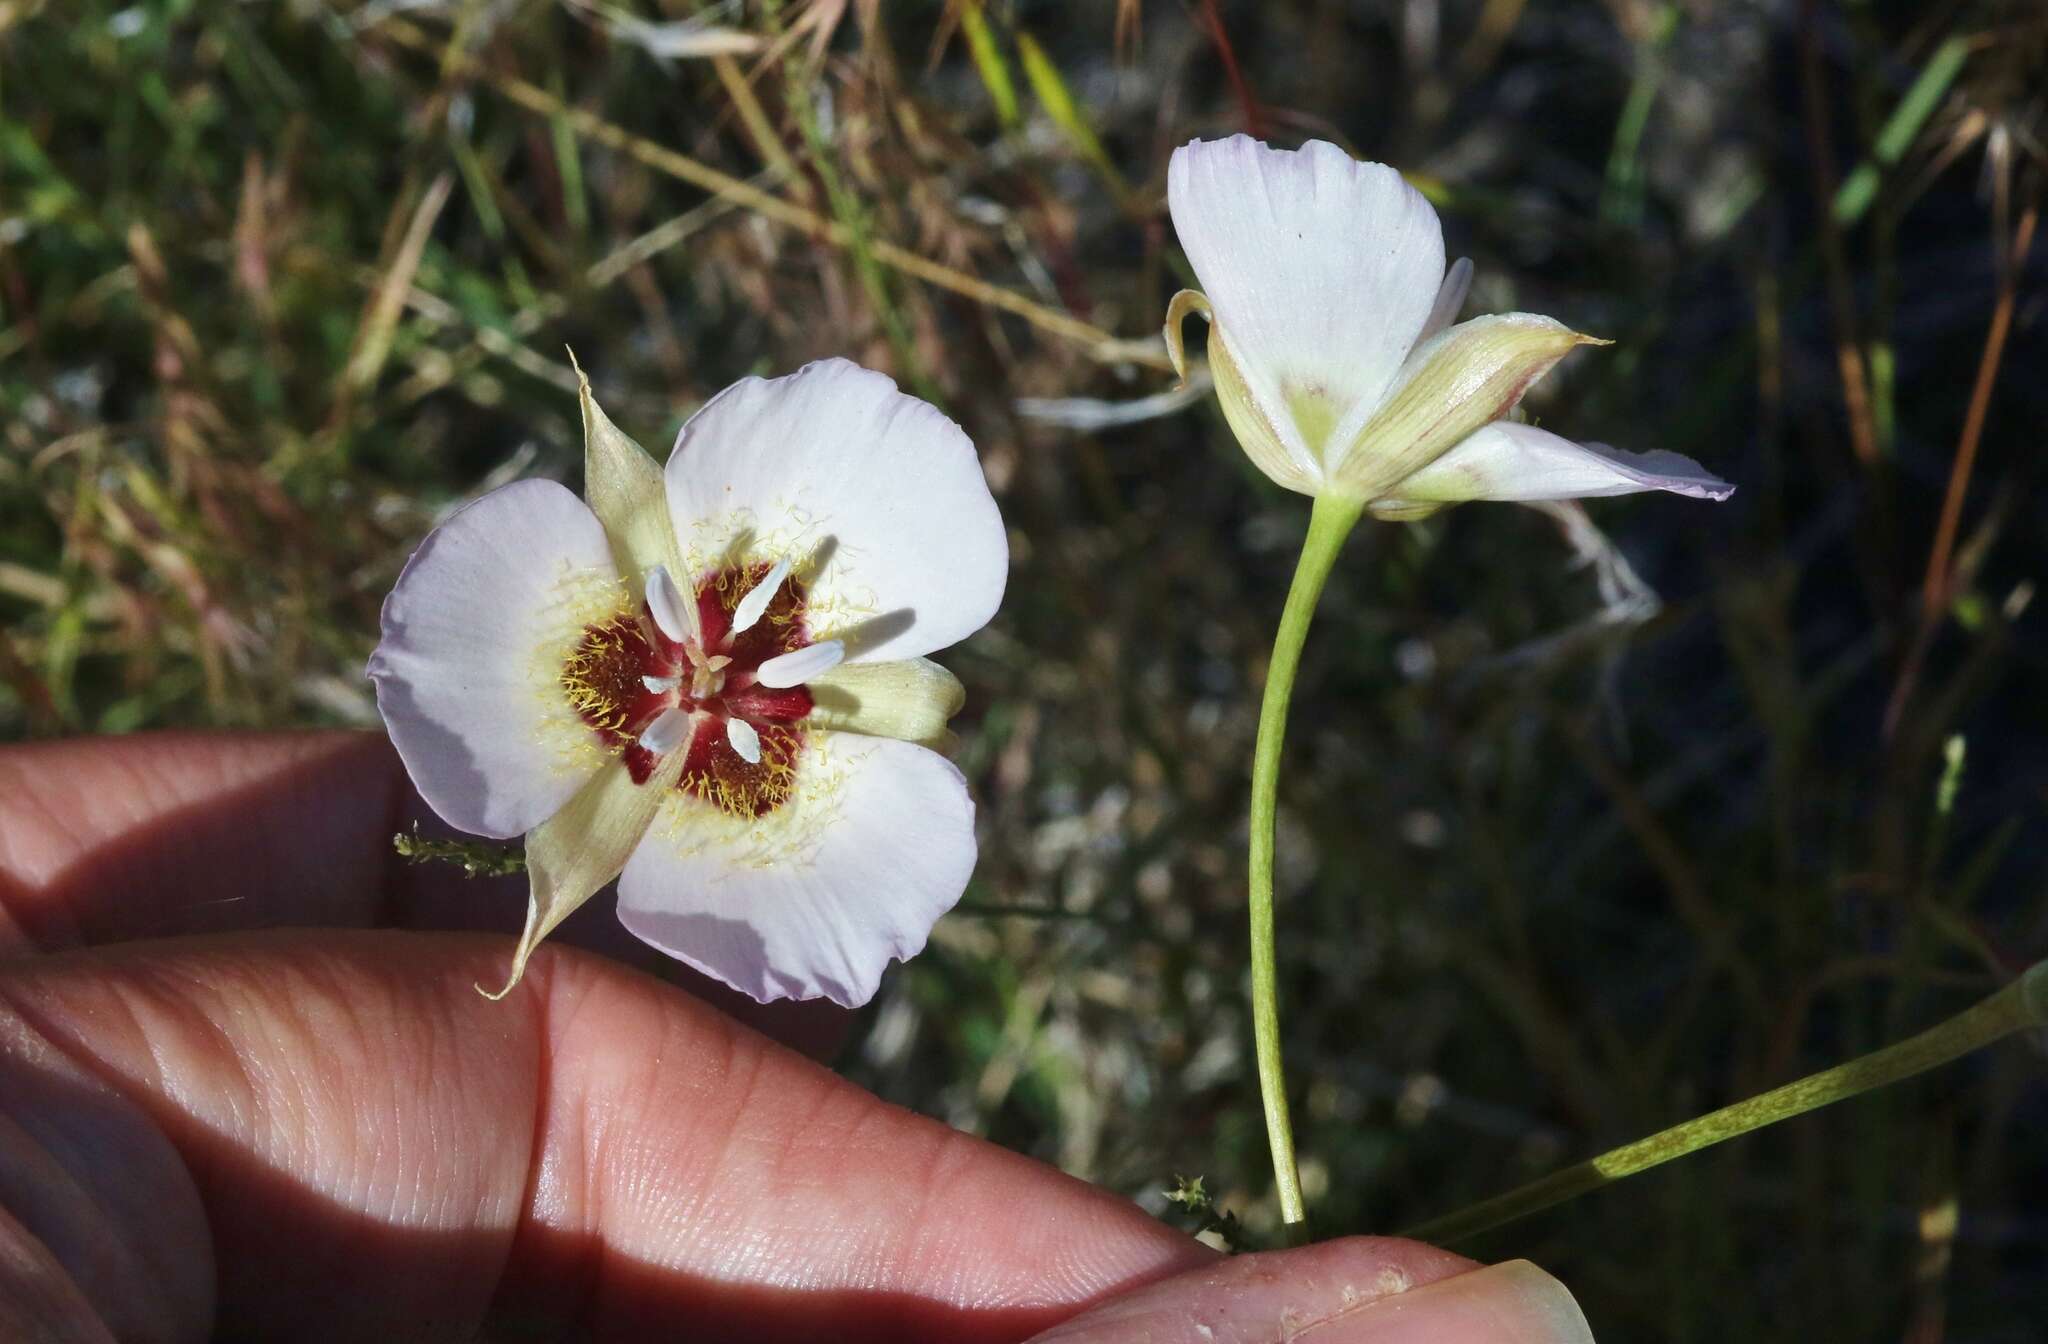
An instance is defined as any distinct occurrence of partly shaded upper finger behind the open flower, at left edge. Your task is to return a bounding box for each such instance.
[0,731,848,1057]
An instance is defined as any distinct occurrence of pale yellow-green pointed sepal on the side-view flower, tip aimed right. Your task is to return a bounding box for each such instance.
[1331,313,1608,500]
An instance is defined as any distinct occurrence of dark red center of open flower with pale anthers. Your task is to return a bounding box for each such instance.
[561,561,840,817]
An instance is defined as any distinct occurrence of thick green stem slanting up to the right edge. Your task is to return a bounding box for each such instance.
[1401,961,2048,1242]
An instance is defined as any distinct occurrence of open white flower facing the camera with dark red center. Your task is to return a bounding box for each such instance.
[369,361,1008,1006]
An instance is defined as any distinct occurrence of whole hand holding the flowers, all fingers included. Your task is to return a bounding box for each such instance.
[0,733,1589,1344]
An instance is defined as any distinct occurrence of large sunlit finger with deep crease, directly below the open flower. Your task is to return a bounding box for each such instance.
[0,932,1210,1340]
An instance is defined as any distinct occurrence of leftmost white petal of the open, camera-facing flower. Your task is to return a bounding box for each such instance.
[369,481,616,836]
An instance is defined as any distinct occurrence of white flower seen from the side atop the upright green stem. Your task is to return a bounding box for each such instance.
[1165,135,1735,518]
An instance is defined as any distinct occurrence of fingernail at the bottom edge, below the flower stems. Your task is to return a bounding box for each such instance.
[1298,1260,1593,1344]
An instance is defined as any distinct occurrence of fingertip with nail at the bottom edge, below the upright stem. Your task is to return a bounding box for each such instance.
[1032,1237,1593,1344]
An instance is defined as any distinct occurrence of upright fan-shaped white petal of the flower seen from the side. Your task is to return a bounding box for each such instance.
[1167,135,1444,473]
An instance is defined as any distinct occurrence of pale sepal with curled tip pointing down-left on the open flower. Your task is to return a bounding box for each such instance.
[477,745,686,1000]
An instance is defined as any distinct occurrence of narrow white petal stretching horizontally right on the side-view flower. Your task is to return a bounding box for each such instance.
[1386,420,1735,504]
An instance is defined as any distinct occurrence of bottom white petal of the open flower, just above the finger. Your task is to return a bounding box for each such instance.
[618,733,975,1008]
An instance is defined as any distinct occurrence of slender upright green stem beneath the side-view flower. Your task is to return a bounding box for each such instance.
[1251,487,1364,1242]
